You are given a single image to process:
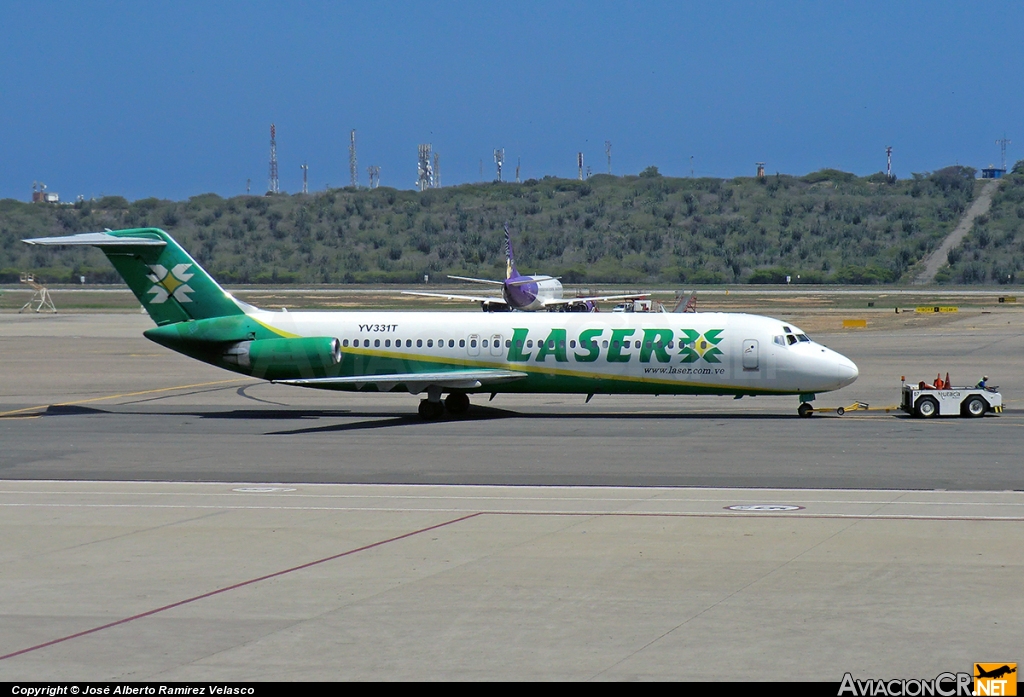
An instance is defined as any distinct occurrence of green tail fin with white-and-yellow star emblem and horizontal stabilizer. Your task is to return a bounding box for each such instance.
[24,227,250,325]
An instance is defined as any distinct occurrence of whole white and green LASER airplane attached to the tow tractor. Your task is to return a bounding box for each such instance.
[25,228,857,419]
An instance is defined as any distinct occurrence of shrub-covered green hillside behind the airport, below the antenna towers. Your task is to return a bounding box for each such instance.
[0,167,1007,285]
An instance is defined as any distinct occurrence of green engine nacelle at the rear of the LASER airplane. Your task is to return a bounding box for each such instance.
[222,337,341,380]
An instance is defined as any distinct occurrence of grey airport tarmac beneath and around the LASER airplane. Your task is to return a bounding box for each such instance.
[0,311,1024,682]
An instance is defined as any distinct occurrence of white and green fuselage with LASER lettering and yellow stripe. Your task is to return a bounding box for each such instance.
[197,310,857,395]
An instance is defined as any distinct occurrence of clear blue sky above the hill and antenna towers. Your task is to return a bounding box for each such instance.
[0,0,1024,200]
